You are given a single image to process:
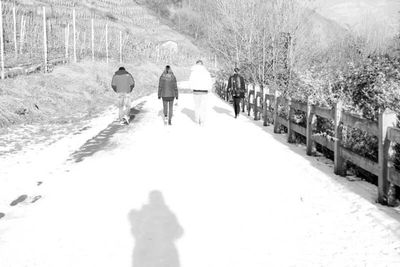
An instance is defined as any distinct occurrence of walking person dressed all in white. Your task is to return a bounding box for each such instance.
[189,60,212,125]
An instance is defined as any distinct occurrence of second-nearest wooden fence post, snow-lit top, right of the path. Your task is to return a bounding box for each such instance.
[334,102,346,176]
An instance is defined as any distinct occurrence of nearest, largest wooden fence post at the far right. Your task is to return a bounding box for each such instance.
[378,109,397,204]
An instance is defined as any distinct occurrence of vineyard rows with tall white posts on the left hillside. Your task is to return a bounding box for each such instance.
[0,0,199,79]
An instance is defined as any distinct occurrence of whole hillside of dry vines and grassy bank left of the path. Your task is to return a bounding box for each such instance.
[0,0,205,128]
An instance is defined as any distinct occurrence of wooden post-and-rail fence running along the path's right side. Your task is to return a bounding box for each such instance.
[216,83,400,205]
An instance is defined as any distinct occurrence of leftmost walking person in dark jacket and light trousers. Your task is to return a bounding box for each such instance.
[111,67,135,124]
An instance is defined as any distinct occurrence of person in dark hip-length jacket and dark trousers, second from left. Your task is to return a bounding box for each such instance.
[158,66,178,125]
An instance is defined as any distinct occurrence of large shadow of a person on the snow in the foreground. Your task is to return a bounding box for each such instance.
[129,191,183,267]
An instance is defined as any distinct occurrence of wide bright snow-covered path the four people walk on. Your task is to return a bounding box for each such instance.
[0,91,400,267]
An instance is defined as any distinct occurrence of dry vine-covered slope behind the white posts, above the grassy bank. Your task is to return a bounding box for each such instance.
[3,0,203,67]
